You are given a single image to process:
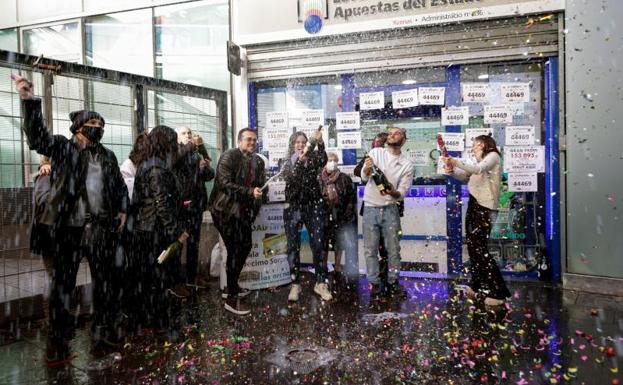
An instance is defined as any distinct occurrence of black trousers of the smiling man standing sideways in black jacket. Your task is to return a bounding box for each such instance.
[212,215,253,296]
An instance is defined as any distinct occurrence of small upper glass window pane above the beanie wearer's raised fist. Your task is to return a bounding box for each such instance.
[22,21,82,63]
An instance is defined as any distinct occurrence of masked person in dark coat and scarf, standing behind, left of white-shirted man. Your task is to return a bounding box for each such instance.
[319,152,355,283]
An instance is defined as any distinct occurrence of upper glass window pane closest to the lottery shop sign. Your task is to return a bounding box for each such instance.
[154,1,229,91]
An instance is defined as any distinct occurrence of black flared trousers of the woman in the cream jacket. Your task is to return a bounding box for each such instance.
[465,195,511,299]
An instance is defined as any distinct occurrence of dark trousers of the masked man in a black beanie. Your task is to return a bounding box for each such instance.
[49,223,123,343]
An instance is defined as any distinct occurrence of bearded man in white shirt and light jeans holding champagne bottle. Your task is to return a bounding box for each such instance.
[361,127,413,296]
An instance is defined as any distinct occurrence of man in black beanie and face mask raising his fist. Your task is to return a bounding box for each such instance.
[14,76,128,363]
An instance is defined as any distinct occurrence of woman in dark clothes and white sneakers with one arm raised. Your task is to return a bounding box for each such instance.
[283,130,333,302]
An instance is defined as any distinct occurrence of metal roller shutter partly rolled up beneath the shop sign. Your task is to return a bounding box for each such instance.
[246,15,559,80]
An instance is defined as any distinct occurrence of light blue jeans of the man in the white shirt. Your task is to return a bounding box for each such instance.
[363,204,402,285]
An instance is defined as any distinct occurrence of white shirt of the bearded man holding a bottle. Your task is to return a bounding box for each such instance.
[361,148,413,207]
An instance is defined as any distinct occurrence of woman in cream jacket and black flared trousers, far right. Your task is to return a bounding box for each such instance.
[441,135,510,306]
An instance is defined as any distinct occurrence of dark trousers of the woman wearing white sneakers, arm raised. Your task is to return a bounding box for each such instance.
[283,202,327,283]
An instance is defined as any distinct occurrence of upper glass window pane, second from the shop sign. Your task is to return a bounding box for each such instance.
[84,9,154,76]
